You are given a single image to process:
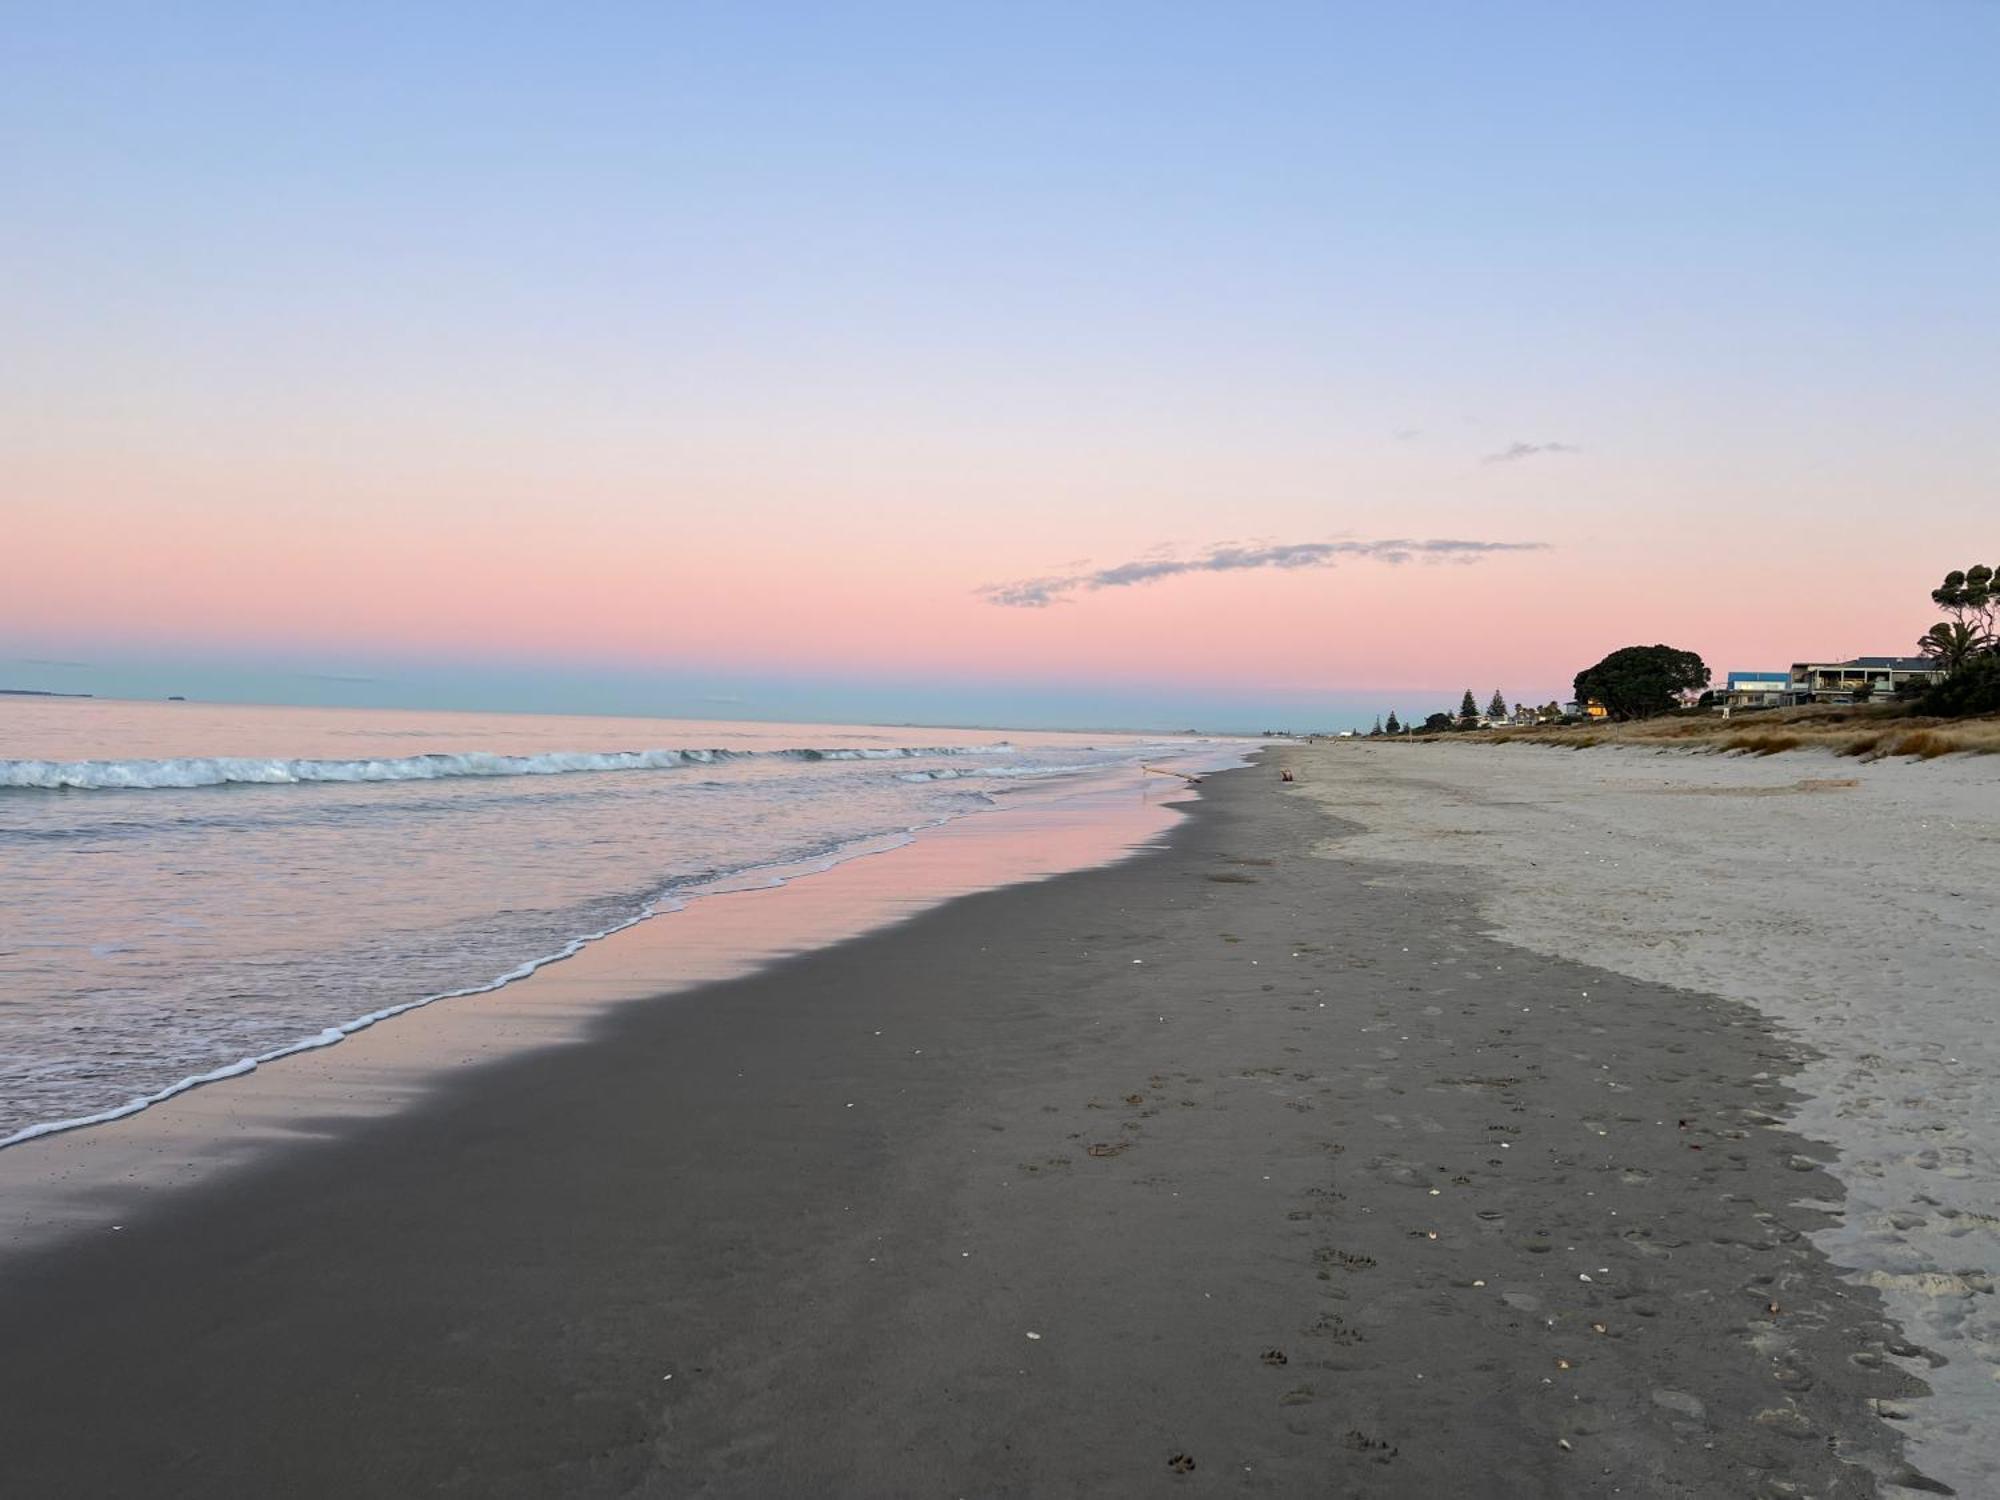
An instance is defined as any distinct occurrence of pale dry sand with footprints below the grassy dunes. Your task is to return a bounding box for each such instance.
[1300,742,2000,1496]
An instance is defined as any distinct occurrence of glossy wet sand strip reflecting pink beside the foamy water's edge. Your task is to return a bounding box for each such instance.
[0,774,1198,1274]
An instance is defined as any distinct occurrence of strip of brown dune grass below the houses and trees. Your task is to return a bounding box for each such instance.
[1410,704,2000,760]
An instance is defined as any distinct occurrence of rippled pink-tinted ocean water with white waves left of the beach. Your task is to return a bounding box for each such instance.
[0,698,1236,1146]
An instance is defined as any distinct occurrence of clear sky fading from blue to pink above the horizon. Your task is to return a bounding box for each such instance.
[0,0,2000,728]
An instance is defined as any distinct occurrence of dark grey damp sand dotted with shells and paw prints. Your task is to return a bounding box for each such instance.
[0,748,1924,1496]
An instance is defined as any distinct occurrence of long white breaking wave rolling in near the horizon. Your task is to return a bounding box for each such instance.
[0,742,1014,792]
